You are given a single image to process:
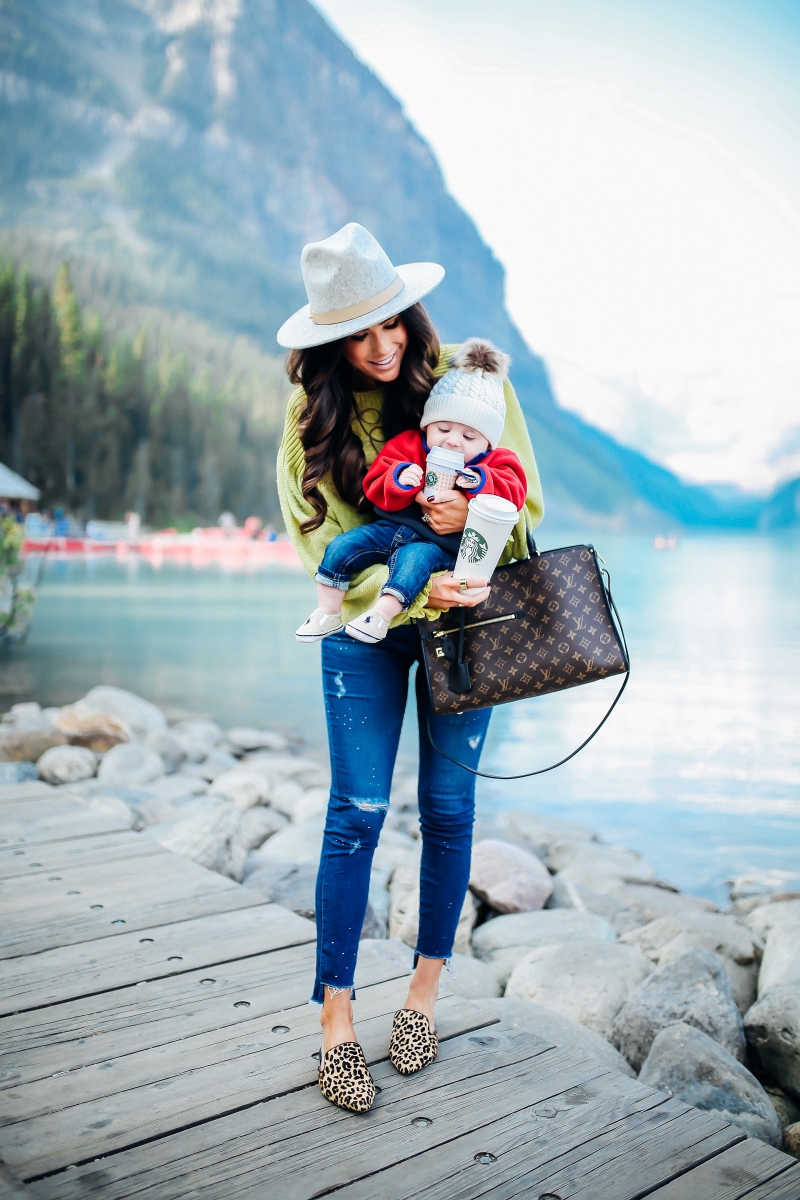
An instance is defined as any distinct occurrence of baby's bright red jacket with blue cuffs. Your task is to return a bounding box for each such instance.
[363,430,528,512]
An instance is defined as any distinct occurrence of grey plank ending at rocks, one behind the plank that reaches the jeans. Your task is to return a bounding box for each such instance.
[0,854,266,959]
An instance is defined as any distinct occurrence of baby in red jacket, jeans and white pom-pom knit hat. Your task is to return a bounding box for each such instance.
[296,338,528,642]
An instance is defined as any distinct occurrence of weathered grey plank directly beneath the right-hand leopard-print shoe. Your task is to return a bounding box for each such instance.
[0,979,497,1178]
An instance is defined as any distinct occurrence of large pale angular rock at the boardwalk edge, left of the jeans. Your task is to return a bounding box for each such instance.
[142,796,245,880]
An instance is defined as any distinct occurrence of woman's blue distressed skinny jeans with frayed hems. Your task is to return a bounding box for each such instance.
[311,625,492,1003]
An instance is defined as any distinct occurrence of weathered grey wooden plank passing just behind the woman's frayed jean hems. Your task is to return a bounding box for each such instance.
[0,936,408,1099]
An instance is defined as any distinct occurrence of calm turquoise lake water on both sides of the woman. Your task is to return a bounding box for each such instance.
[0,534,800,901]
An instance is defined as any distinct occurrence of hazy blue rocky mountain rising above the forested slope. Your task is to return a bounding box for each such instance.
[0,0,777,526]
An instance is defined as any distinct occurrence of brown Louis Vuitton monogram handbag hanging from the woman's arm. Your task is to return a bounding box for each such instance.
[419,546,627,714]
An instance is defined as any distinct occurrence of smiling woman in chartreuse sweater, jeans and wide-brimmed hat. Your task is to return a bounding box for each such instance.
[278,224,542,1111]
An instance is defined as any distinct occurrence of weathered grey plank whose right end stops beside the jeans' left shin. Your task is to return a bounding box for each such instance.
[0,904,315,1017]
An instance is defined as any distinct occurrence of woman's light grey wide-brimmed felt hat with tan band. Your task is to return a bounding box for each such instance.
[278,221,445,350]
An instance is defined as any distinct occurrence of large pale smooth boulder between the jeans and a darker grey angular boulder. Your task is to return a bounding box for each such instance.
[506,942,652,1042]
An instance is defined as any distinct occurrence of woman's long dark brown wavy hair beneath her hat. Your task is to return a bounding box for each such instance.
[287,304,439,533]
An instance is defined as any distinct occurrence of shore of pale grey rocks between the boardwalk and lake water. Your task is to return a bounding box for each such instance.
[0,686,800,1158]
